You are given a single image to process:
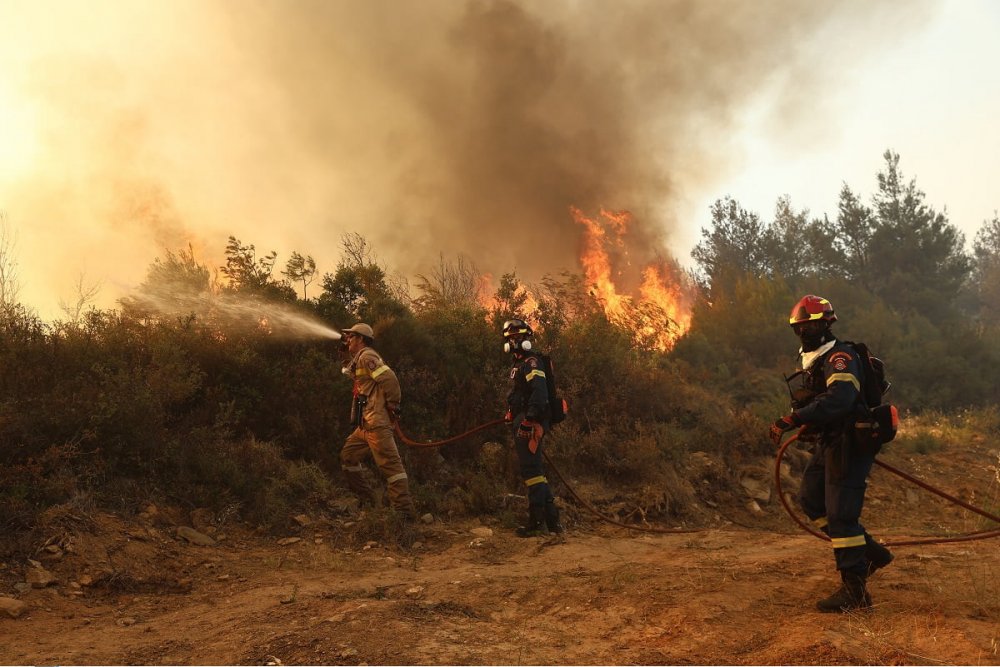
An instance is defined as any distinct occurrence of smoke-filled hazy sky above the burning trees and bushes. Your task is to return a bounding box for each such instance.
[0,0,1000,318]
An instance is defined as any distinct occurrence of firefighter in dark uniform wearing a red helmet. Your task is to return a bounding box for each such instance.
[771,294,893,612]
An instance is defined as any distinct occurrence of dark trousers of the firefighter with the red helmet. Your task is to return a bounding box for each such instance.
[799,434,878,578]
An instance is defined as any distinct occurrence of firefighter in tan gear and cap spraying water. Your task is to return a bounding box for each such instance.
[340,324,415,518]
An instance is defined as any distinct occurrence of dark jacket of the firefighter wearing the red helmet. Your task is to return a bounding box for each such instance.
[794,340,864,433]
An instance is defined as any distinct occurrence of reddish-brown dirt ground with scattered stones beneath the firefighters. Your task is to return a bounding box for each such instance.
[0,442,1000,665]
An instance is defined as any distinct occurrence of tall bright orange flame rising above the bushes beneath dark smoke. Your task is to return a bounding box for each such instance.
[570,207,691,351]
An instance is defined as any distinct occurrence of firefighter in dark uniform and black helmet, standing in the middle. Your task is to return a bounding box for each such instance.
[503,319,563,537]
